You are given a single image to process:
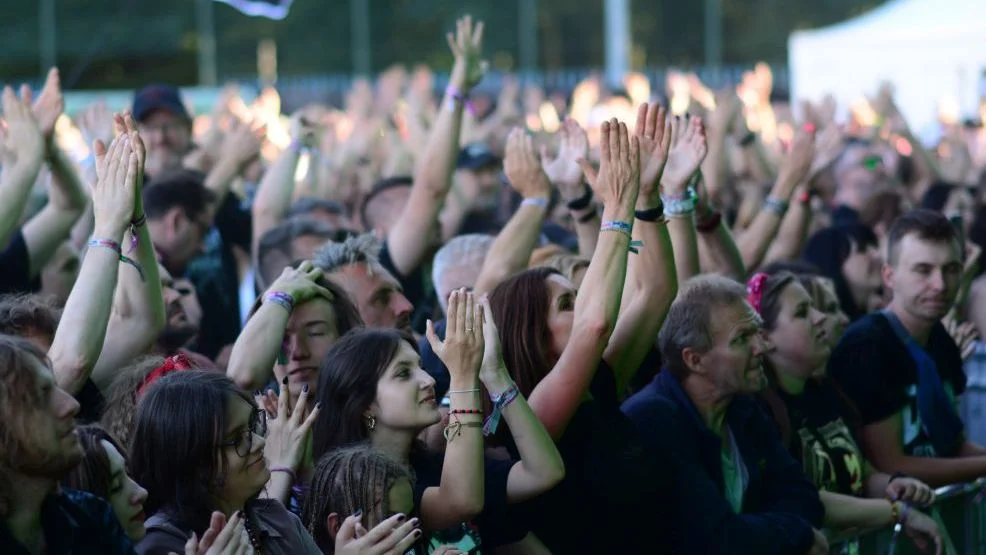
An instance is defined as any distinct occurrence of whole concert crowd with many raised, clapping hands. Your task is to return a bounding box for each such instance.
[0,11,986,555]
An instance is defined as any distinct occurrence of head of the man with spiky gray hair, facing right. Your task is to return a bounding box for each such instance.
[313,233,414,332]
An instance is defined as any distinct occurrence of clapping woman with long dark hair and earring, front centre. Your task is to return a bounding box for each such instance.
[312,290,564,553]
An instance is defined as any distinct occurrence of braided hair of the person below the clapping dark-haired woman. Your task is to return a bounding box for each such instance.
[301,442,414,554]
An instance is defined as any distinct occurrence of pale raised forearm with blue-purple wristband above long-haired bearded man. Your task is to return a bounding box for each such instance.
[48,226,123,394]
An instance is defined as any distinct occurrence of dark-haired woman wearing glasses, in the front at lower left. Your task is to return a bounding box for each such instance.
[130,370,320,555]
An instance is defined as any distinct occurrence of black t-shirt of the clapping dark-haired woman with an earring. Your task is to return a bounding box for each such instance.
[411,452,529,555]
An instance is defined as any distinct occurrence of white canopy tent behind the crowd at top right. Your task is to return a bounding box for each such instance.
[788,0,986,135]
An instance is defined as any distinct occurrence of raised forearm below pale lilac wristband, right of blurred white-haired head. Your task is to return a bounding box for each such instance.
[474,204,545,295]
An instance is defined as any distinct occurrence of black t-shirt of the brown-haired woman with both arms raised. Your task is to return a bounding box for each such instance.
[507,361,673,554]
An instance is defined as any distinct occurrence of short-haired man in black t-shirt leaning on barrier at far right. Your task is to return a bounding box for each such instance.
[828,210,986,486]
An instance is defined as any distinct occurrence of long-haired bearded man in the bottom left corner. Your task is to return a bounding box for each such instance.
[0,335,134,555]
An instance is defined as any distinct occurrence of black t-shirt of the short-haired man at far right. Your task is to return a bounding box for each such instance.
[828,313,966,457]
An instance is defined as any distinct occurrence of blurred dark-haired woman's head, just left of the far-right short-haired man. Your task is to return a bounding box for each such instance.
[804,224,883,321]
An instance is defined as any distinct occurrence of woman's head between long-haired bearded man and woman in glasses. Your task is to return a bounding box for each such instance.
[62,424,147,543]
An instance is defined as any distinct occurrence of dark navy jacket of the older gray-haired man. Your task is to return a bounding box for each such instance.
[622,371,824,555]
